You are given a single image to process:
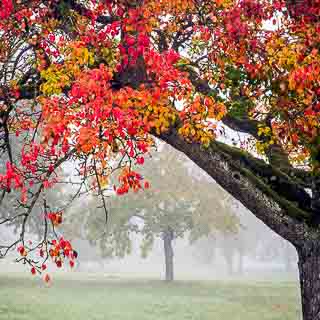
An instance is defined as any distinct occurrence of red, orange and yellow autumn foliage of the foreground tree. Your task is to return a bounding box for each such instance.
[0,0,320,281]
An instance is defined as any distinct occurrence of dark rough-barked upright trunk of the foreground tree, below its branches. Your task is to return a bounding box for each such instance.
[297,241,320,320]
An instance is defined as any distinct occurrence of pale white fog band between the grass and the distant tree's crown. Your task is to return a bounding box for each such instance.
[0,218,298,280]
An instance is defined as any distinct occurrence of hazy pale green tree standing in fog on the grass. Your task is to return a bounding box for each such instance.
[82,147,237,281]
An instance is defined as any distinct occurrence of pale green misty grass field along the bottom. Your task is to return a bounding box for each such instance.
[0,274,301,320]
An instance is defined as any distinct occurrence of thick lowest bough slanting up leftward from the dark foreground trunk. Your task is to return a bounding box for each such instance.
[160,129,311,245]
